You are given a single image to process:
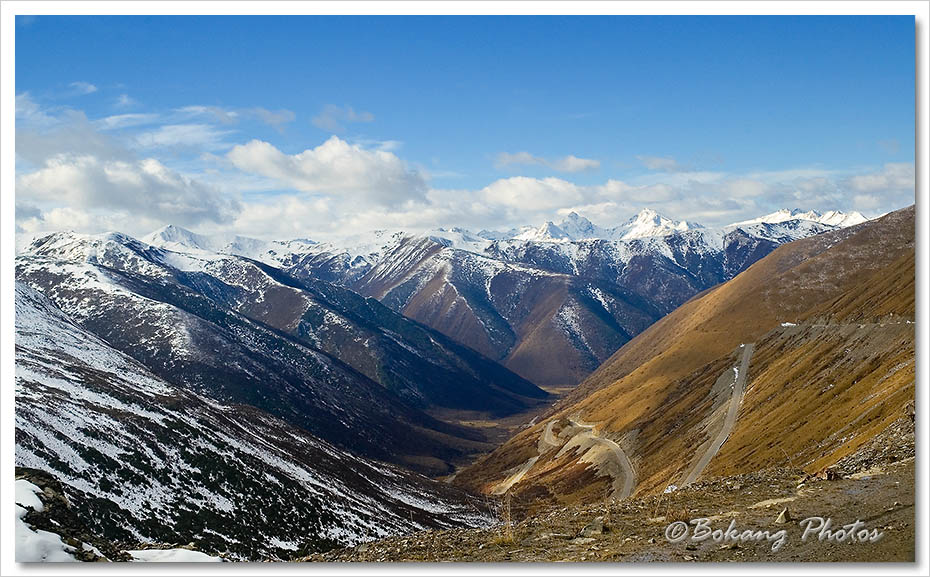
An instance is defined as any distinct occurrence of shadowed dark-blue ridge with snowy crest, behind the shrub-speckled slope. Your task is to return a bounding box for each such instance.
[16,233,546,474]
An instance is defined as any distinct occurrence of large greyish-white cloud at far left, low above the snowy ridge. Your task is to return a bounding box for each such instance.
[16,154,240,230]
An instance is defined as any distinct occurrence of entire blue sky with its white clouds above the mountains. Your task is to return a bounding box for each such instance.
[16,17,915,237]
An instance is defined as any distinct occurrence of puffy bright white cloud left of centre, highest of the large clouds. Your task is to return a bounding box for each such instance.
[227,136,427,206]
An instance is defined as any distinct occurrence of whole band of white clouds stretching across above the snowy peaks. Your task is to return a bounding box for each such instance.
[15,93,914,240]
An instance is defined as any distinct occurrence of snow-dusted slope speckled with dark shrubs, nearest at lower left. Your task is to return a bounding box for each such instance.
[16,282,489,558]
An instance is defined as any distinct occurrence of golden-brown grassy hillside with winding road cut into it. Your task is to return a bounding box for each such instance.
[457,207,914,502]
